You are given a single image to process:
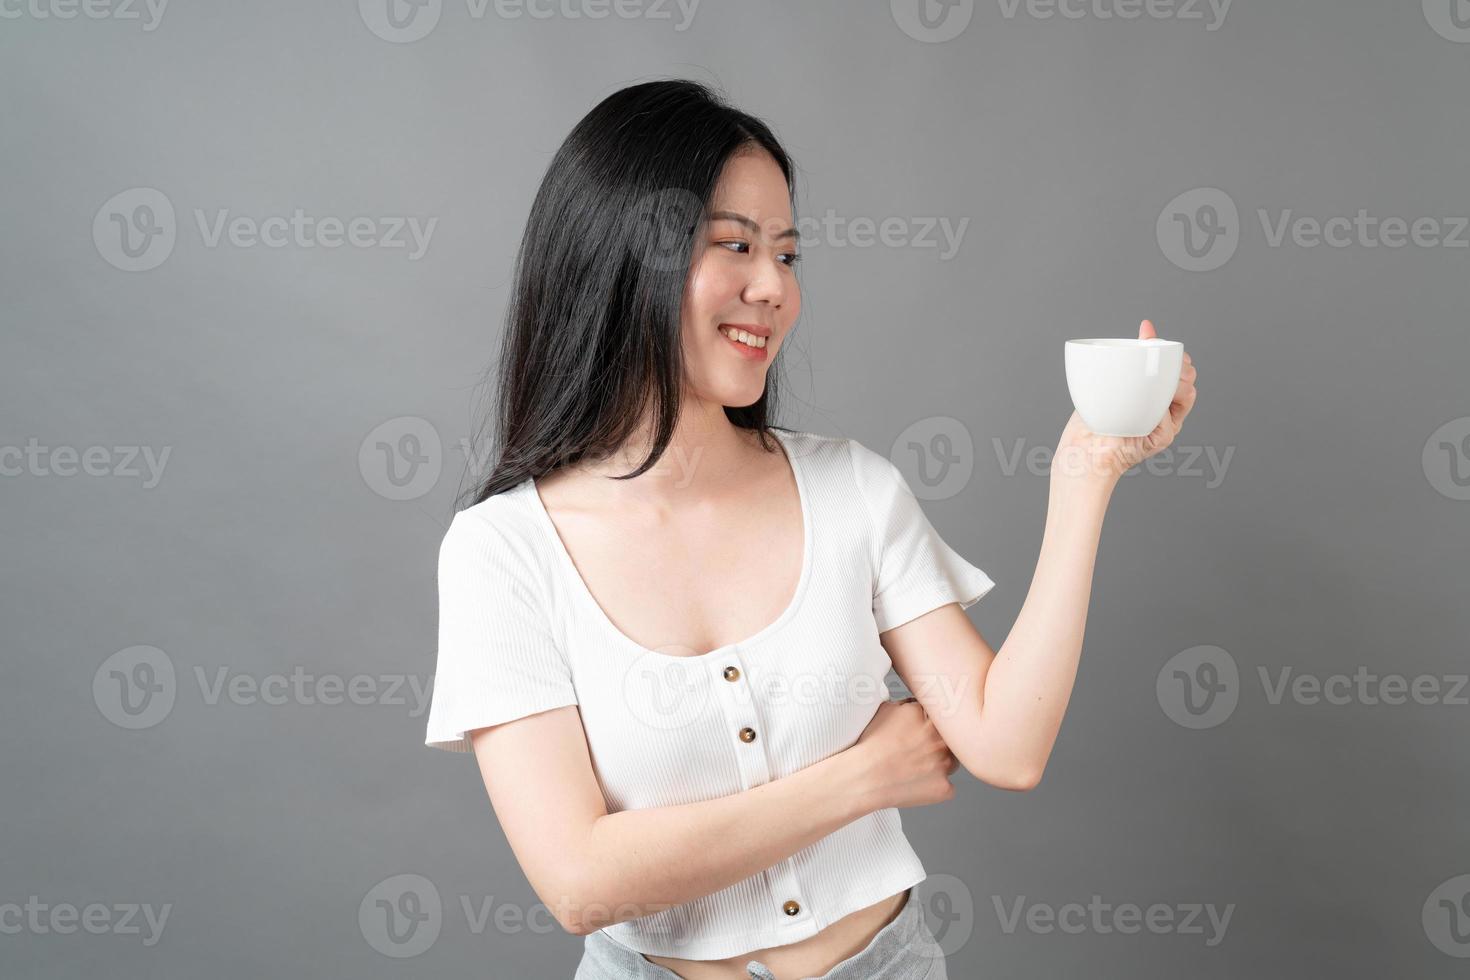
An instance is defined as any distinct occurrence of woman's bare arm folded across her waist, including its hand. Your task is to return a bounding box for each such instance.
[472,701,957,936]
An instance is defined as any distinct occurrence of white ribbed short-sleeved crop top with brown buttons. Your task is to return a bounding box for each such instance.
[425,429,994,959]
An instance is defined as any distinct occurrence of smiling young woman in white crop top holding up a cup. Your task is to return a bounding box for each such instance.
[426,81,1195,980]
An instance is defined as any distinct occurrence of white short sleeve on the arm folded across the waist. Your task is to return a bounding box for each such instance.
[425,511,576,752]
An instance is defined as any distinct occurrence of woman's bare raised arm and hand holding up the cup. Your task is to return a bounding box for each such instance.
[879,320,1197,790]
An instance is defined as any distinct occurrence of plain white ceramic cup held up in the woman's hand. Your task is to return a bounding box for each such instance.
[1064,336,1185,435]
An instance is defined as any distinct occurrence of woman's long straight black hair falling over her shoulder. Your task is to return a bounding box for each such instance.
[469,79,795,504]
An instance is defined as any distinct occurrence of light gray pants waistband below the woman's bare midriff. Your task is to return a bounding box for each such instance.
[573,886,950,980]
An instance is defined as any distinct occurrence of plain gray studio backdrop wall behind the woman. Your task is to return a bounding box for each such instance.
[0,0,1470,980]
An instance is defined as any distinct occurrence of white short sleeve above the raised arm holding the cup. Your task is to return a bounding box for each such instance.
[848,439,995,633]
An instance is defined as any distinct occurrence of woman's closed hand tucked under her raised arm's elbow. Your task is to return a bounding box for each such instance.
[853,698,960,810]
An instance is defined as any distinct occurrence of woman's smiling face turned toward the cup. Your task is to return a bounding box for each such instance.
[681,150,801,407]
